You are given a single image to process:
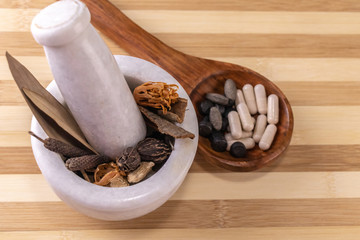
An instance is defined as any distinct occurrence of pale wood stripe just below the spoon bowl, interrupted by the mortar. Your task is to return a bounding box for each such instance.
[0,172,360,202]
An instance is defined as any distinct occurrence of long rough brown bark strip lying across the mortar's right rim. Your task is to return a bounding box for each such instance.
[139,106,195,139]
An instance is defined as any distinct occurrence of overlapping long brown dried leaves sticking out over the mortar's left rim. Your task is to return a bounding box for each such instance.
[6,52,96,153]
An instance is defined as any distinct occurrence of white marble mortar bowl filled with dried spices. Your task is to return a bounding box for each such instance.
[31,56,198,221]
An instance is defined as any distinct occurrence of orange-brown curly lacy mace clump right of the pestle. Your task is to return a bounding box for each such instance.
[134,82,179,114]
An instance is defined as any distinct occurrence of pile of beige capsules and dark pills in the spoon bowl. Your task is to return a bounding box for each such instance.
[199,79,279,158]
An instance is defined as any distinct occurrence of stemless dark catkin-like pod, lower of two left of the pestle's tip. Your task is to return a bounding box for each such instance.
[65,155,111,171]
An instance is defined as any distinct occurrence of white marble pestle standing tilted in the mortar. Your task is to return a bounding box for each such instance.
[31,0,146,157]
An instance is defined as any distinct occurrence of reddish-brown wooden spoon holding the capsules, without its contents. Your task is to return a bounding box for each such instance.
[82,0,294,171]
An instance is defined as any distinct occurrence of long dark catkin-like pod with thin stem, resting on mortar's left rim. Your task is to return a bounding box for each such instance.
[29,131,94,158]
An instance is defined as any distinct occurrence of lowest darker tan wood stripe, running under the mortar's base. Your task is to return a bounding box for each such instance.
[0,199,360,231]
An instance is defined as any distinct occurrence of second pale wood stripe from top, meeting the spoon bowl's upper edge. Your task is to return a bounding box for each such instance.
[4,56,360,83]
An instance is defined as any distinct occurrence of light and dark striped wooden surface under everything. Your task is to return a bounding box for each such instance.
[0,0,360,240]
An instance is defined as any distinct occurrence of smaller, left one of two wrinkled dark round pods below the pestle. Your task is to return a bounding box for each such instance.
[116,147,141,172]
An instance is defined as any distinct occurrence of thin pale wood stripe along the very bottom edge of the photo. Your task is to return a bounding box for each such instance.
[0,226,360,240]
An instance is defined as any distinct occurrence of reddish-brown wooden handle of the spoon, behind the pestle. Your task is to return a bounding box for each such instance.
[82,0,214,94]
